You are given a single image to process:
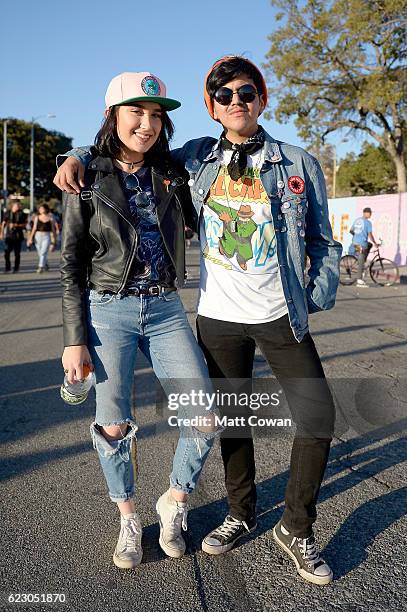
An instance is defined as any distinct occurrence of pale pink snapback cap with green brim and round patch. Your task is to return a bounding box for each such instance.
[105,72,181,110]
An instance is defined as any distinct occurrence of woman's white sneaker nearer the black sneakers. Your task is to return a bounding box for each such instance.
[155,491,188,559]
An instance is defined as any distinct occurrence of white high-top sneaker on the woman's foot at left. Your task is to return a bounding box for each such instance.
[113,512,143,569]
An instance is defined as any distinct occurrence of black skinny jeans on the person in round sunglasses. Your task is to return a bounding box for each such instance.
[197,315,335,538]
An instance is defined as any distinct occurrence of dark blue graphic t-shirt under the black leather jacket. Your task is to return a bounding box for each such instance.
[119,168,176,289]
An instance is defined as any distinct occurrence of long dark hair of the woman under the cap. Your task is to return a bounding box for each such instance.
[95,104,174,166]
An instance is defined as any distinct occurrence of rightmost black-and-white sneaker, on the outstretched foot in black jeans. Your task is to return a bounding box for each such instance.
[273,521,333,584]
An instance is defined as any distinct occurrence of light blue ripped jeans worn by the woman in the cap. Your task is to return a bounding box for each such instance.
[87,290,216,502]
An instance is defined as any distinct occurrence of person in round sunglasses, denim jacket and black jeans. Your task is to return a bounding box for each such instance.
[54,56,342,584]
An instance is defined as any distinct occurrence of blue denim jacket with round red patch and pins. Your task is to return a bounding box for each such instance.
[65,132,342,342]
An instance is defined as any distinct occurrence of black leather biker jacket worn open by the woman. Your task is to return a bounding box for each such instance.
[61,157,197,346]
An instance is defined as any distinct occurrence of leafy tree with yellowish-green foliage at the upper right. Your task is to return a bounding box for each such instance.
[265,0,407,191]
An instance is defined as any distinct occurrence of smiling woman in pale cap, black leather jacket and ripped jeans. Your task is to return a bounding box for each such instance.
[61,72,215,568]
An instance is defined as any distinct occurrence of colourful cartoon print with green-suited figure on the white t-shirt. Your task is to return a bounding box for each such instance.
[203,166,276,273]
